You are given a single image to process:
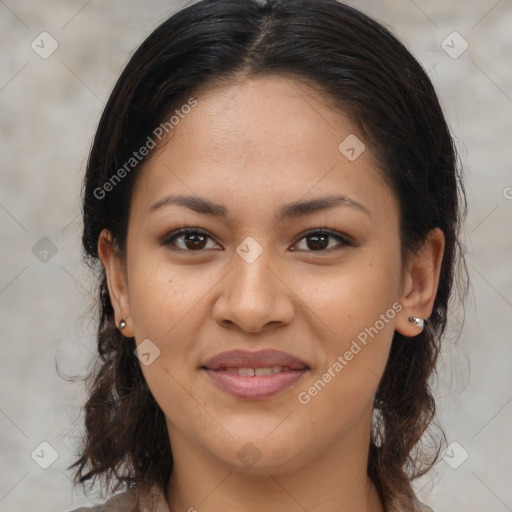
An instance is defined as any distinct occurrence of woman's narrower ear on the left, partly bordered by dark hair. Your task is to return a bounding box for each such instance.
[98,229,134,338]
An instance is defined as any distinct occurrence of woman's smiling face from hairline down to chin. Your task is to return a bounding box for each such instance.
[104,77,440,472]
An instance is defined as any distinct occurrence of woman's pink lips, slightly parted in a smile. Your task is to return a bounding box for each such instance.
[201,350,310,400]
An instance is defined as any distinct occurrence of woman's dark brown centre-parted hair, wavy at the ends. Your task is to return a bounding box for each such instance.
[71,0,467,508]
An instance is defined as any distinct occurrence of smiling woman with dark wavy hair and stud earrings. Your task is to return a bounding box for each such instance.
[70,0,464,512]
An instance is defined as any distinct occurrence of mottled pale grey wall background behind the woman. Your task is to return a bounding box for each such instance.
[0,0,512,512]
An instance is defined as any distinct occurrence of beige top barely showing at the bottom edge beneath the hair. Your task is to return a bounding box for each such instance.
[72,486,433,512]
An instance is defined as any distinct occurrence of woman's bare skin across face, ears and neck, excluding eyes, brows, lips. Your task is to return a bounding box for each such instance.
[98,77,444,512]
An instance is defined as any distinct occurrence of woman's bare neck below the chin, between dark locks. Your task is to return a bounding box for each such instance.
[167,416,383,512]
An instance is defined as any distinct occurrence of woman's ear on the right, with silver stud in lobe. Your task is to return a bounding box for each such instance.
[395,228,445,336]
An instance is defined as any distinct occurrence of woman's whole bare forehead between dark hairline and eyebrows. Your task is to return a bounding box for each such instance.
[130,77,392,219]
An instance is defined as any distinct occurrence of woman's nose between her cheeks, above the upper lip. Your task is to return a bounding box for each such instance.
[213,251,295,334]
